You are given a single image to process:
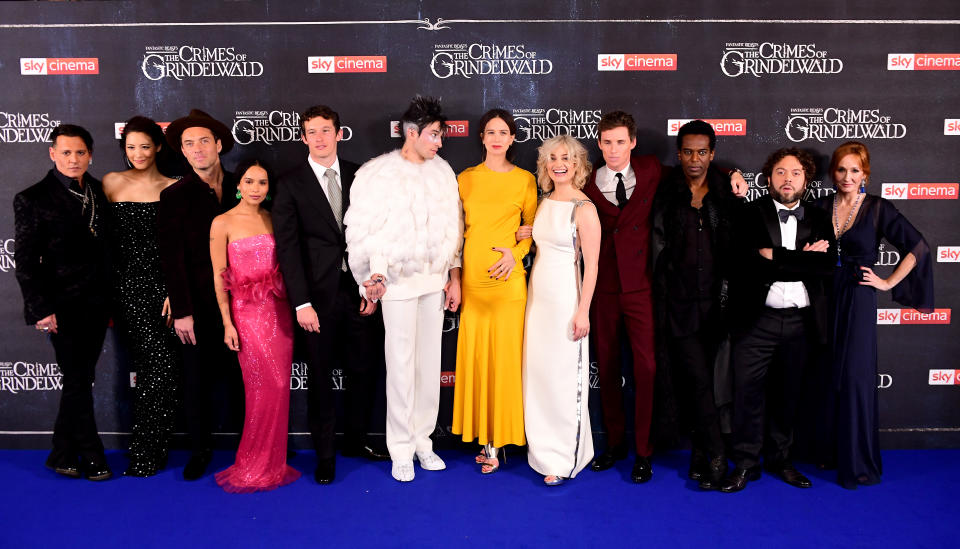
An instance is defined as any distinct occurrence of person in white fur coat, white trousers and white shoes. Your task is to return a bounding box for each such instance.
[343,96,463,482]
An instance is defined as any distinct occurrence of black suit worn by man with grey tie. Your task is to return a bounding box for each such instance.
[273,159,383,459]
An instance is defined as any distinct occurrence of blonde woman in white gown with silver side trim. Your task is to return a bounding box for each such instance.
[521,135,600,486]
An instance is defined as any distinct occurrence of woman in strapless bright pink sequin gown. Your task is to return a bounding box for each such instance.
[210,160,300,493]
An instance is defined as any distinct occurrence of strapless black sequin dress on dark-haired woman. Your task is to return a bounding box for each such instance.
[111,202,179,476]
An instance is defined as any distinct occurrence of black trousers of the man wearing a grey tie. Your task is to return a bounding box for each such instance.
[305,273,384,459]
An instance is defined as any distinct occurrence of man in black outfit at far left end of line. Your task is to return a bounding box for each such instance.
[13,124,112,480]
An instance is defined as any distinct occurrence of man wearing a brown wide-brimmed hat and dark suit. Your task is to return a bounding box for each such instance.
[157,109,242,480]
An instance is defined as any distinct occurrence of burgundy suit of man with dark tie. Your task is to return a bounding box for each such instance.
[583,155,662,457]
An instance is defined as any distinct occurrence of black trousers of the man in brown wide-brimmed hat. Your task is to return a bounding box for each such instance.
[180,311,244,452]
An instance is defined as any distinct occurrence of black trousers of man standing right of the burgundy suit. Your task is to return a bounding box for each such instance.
[670,328,725,457]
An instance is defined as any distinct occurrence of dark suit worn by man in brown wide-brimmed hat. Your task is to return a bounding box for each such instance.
[157,171,243,452]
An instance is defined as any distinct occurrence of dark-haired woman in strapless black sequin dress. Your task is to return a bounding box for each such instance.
[103,116,179,477]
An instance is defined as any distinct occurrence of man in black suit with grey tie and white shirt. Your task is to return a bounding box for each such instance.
[273,105,389,484]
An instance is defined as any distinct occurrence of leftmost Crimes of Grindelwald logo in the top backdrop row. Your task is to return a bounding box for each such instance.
[140,46,263,80]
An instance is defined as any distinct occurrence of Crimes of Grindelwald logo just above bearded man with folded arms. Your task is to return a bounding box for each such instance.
[783,107,907,143]
